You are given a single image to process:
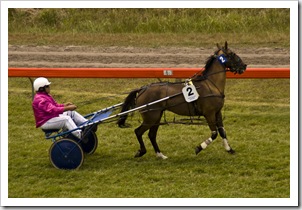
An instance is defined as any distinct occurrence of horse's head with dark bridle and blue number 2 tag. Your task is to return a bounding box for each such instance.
[216,42,247,74]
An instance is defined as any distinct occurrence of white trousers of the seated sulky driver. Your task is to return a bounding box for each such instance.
[41,111,87,138]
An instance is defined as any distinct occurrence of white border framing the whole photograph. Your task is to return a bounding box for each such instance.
[1,1,299,207]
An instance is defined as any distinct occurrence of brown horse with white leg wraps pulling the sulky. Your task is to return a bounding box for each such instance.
[118,42,247,159]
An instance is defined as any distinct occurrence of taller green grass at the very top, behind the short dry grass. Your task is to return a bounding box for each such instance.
[9,8,289,34]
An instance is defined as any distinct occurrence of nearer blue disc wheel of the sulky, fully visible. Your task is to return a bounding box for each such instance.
[49,138,84,170]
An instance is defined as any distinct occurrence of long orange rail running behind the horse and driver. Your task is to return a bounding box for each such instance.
[8,68,290,78]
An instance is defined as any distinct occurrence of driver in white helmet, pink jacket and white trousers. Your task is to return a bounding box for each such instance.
[32,77,87,139]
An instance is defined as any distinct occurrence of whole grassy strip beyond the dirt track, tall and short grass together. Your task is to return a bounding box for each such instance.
[8,8,290,47]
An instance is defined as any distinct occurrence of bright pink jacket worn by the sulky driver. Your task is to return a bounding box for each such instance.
[32,92,64,128]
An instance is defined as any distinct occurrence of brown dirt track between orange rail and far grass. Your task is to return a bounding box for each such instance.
[8,45,290,68]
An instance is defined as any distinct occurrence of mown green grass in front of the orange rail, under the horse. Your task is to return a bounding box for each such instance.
[8,78,290,198]
